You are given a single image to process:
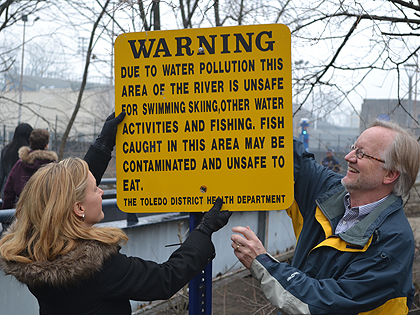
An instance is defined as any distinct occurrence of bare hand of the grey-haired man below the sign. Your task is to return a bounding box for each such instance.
[230,226,267,269]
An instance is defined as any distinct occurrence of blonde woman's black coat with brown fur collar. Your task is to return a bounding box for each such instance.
[1,146,215,315]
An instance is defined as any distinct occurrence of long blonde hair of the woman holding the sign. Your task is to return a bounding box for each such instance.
[0,158,128,263]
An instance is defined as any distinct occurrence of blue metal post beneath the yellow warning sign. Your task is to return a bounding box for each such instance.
[189,212,212,315]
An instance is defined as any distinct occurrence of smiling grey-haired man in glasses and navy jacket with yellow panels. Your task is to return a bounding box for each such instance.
[231,120,420,315]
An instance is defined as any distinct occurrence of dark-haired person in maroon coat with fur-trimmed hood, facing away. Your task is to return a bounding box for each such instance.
[2,129,58,209]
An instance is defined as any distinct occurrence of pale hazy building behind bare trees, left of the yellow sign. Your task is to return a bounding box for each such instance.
[0,73,114,150]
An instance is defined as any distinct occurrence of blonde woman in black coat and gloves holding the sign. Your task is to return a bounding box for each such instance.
[0,112,231,315]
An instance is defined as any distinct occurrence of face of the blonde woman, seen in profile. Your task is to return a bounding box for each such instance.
[80,172,104,226]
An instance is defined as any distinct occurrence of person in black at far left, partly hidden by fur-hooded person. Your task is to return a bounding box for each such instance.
[0,123,33,198]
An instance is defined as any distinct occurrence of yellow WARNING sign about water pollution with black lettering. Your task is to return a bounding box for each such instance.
[115,24,293,213]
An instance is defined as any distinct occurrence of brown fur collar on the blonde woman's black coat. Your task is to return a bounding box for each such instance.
[0,236,120,287]
